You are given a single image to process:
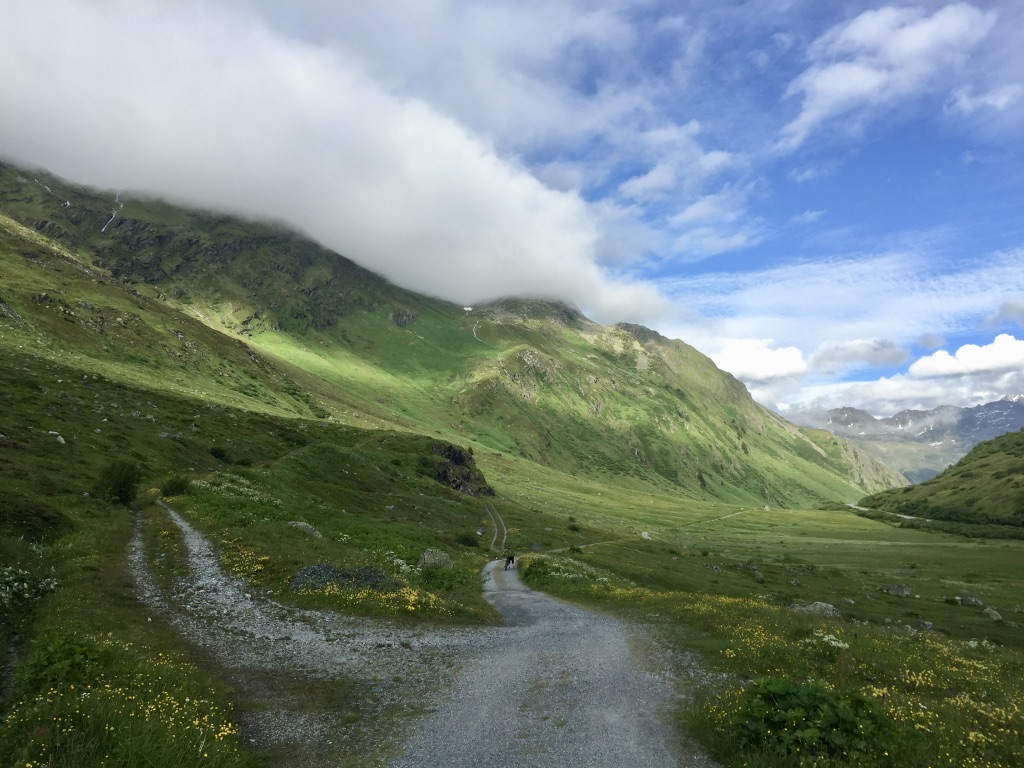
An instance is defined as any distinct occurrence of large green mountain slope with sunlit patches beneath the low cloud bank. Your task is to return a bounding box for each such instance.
[0,161,900,506]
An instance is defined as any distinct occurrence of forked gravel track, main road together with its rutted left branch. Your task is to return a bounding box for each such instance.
[129,502,711,768]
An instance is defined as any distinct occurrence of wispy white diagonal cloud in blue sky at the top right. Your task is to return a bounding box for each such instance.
[778,3,995,152]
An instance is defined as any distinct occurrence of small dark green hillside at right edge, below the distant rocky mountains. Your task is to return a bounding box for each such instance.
[859,432,1024,539]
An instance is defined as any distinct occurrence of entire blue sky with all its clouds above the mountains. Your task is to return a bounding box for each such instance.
[0,0,1024,423]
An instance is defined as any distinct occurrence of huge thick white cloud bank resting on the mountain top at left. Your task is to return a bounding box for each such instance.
[0,0,665,319]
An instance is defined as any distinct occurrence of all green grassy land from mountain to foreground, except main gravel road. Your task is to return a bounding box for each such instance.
[6,164,1024,768]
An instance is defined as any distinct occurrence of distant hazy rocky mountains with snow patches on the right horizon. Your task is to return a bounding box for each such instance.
[815,394,1024,482]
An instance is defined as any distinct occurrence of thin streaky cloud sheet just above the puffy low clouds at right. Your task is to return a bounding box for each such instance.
[664,246,1024,356]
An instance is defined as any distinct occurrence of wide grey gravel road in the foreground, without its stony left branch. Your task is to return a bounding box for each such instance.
[391,561,680,768]
